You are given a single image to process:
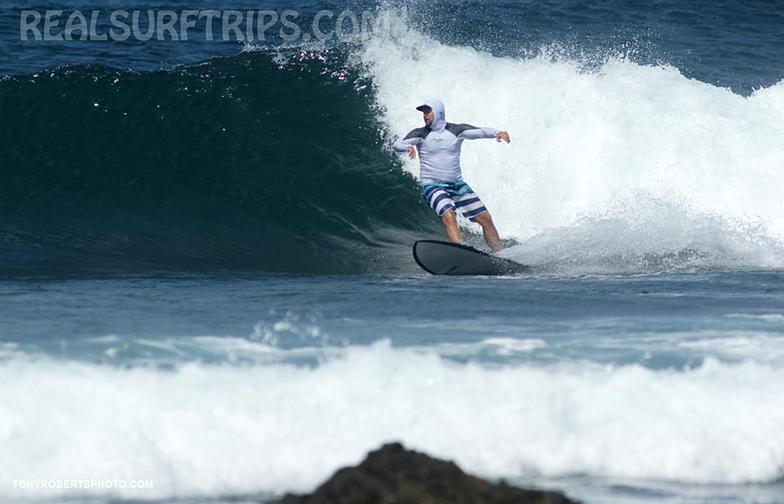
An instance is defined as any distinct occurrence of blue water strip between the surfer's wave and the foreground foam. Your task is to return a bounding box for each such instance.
[6,271,784,370]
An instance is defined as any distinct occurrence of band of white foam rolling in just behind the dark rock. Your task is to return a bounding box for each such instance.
[0,344,784,500]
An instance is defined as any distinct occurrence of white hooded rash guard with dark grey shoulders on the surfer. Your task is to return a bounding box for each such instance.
[392,99,498,185]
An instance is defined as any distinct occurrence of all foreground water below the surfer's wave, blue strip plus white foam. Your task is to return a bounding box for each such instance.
[0,271,784,503]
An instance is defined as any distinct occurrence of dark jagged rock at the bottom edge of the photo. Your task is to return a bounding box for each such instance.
[280,443,576,504]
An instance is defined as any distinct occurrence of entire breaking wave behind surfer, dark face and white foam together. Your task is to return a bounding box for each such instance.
[0,9,784,273]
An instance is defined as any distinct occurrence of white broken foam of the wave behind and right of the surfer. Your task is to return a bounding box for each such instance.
[357,9,784,267]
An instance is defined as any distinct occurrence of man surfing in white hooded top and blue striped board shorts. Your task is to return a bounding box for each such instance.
[392,99,510,252]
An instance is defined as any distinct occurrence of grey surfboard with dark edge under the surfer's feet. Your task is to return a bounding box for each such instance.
[413,240,530,275]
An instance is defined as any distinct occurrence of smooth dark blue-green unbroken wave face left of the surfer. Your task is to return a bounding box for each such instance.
[0,52,440,272]
